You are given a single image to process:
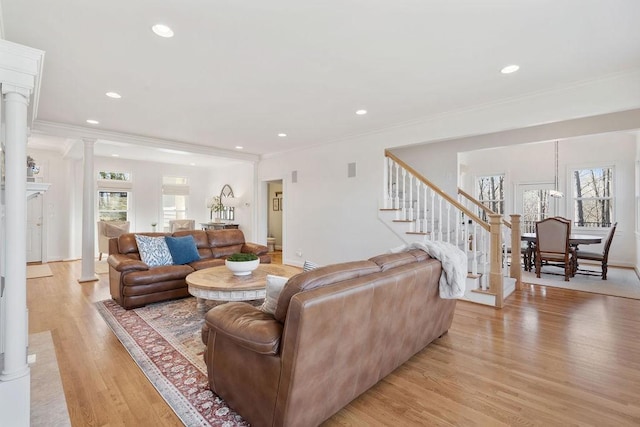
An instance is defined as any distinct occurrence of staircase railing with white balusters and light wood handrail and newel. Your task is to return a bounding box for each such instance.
[382,151,520,307]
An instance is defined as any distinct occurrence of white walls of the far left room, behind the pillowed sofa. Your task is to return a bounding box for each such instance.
[28,149,254,262]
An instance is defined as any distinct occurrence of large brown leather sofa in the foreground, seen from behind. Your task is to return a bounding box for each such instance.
[202,250,456,427]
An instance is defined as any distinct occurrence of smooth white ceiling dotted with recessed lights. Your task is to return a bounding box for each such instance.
[0,0,640,164]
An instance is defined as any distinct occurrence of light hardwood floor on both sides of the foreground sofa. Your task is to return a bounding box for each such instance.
[27,261,640,426]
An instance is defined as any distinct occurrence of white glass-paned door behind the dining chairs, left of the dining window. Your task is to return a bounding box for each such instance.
[514,182,555,233]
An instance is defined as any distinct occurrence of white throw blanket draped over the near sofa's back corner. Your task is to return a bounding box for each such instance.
[389,240,467,299]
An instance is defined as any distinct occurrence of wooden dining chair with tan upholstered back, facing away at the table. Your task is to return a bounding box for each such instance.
[535,217,575,282]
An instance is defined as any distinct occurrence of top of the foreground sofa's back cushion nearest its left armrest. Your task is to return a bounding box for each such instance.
[275,258,380,323]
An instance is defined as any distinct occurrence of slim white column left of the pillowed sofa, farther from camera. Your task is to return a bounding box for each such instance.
[78,138,98,283]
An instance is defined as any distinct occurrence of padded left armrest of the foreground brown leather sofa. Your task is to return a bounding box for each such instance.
[202,302,282,355]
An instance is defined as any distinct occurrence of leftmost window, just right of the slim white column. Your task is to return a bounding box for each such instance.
[98,171,132,221]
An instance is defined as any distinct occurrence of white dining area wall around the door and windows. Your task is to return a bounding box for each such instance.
[459,132,636,267]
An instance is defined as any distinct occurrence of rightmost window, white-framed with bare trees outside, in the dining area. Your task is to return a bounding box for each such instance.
[572,167,614,227]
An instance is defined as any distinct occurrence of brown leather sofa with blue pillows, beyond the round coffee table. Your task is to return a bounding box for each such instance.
[107,230,271,310]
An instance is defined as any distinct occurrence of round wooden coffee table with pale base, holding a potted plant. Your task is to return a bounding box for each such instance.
[185,264,302,308]
